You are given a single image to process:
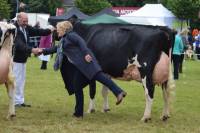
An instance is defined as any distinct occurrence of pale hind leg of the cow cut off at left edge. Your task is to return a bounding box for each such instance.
[5,73,16,119]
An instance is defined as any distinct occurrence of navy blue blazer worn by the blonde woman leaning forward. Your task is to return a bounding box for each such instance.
[43,31,102,80]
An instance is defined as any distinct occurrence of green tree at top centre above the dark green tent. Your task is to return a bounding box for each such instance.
[75,0,111,14]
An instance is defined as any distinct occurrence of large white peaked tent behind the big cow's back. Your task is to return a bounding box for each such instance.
[120,4,176,28]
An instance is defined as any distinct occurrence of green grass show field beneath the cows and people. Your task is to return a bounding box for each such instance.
[0,57,200,133]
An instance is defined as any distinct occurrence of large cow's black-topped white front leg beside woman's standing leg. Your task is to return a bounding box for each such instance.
[87,81,96,113]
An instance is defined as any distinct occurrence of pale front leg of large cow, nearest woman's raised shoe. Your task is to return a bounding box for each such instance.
[102,85,110,112]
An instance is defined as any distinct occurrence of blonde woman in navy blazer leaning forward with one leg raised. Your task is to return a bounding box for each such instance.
[41,21,126,118]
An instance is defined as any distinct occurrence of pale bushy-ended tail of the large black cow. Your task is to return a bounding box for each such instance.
[166,49,176,105]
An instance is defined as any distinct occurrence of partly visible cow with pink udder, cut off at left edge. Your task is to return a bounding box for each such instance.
[0,22,16,118]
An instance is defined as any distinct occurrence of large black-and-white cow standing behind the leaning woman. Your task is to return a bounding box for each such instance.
[74,23,174,122]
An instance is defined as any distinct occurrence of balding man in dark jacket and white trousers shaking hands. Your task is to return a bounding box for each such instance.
[13,12,53,107]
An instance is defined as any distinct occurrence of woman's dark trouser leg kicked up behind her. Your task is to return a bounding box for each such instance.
[94,72,122,97]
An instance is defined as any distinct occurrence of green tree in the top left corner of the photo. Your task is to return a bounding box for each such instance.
[0,0,11,20]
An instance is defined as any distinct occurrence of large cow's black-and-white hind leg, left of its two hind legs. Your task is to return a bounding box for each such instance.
[141,76,154,122]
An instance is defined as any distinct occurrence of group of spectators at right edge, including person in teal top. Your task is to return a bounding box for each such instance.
[172,29,200,80]
